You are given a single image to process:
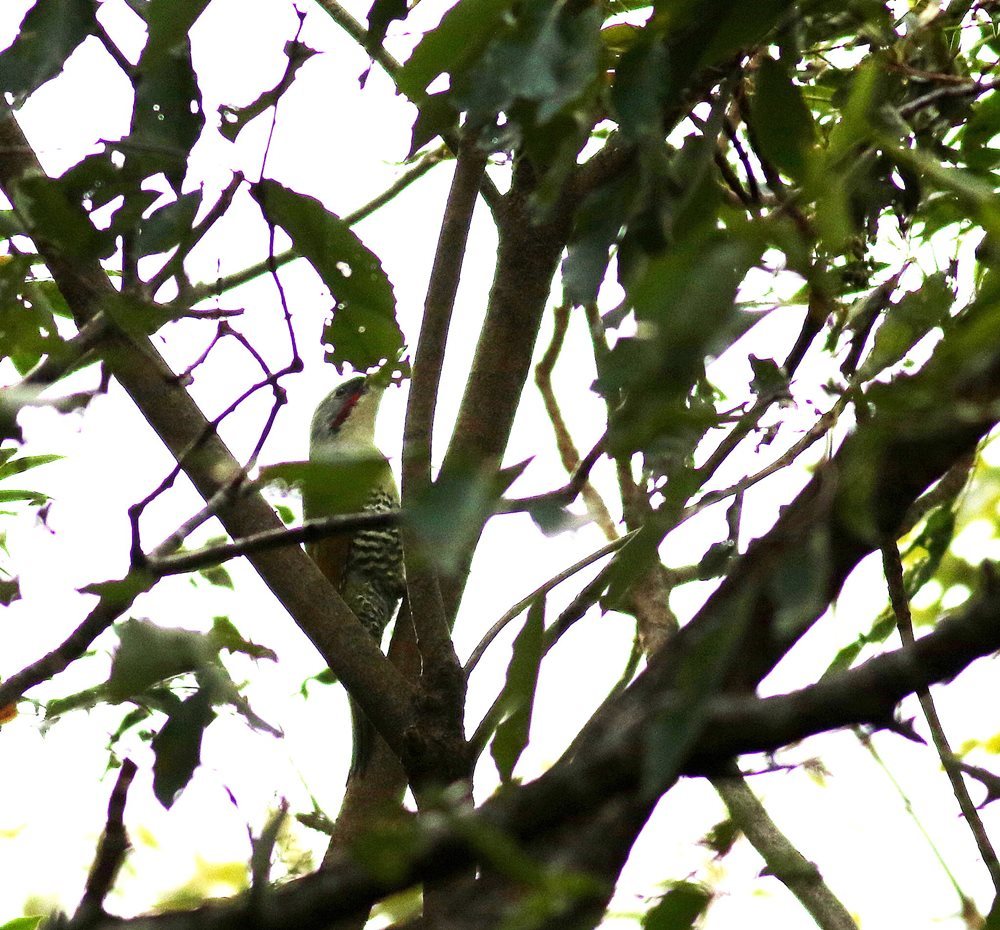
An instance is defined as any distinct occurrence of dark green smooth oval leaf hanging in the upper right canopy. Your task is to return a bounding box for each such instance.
[752,58,816,179]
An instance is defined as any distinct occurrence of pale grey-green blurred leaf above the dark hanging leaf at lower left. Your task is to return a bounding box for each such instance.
[108,619,215,701]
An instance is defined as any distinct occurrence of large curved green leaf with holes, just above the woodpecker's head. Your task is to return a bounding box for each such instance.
[251,180,403,371]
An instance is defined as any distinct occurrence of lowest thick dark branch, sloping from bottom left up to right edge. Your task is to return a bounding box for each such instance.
[60,580,1000,930]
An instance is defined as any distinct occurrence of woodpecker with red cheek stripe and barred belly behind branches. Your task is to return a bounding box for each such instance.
[303,376,406,780]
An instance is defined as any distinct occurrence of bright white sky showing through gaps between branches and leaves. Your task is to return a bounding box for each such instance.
[0,0,1000,930]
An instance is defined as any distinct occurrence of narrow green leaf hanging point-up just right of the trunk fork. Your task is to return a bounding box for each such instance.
[490,597,545,782]
